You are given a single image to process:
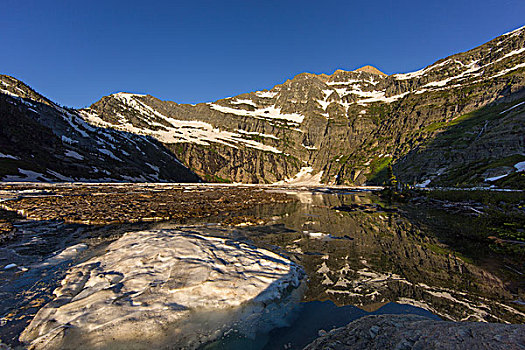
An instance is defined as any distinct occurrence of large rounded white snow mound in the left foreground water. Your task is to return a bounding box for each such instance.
[20,230,304,349]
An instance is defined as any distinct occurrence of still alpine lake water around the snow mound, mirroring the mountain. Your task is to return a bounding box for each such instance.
[0,185,525,349]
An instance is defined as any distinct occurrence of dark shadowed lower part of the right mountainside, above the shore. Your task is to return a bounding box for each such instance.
[393,89,525,188]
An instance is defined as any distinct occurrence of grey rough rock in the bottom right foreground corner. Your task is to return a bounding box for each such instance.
[305,315,525,350]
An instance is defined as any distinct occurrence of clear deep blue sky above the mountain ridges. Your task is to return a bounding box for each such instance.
[0,0,525,107]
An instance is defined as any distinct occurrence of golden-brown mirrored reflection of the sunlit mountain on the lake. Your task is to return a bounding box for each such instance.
[238,192,525,323]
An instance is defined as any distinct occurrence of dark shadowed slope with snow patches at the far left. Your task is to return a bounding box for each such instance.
[0,75,199,182]
